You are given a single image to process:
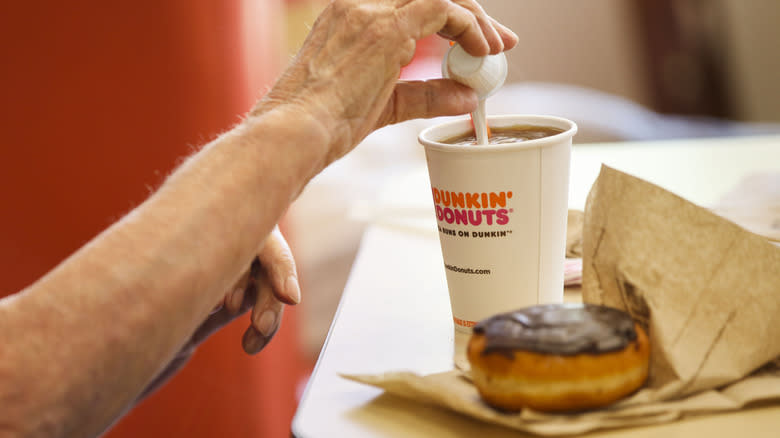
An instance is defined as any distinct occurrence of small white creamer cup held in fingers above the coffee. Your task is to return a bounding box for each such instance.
[441,44,507,99]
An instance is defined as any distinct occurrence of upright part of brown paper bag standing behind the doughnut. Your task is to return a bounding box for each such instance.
[583,166,780,400]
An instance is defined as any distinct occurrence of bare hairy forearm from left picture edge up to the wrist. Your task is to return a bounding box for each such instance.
[0,106,327,436]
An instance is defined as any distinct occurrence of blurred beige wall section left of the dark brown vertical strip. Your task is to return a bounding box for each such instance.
[481,0,650,105]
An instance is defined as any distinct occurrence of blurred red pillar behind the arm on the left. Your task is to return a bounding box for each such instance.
[0,0,301,438]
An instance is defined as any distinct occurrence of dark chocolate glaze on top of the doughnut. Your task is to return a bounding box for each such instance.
[474,304,636,357]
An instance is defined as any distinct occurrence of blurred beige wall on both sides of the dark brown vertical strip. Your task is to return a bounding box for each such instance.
[481,0,780,122]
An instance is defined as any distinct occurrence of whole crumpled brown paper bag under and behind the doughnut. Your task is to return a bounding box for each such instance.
[344,166,780,436]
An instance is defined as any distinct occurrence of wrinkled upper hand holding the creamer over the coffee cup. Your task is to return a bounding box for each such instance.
[251,0,517,165]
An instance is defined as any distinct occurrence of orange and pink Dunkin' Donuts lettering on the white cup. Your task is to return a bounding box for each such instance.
[433,188,512,226]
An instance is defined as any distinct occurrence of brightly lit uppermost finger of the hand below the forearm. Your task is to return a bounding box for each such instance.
[258,226,301,304]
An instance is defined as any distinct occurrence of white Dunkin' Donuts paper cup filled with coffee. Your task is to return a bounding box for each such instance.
[419,115,577,333]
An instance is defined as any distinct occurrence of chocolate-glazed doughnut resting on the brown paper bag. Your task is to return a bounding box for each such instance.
[466,304,650,412]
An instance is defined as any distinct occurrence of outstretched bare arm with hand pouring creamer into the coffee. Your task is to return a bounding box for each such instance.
[0,0,516,437]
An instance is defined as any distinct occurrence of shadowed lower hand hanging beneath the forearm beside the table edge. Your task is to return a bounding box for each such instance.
[139,227,300,400]
